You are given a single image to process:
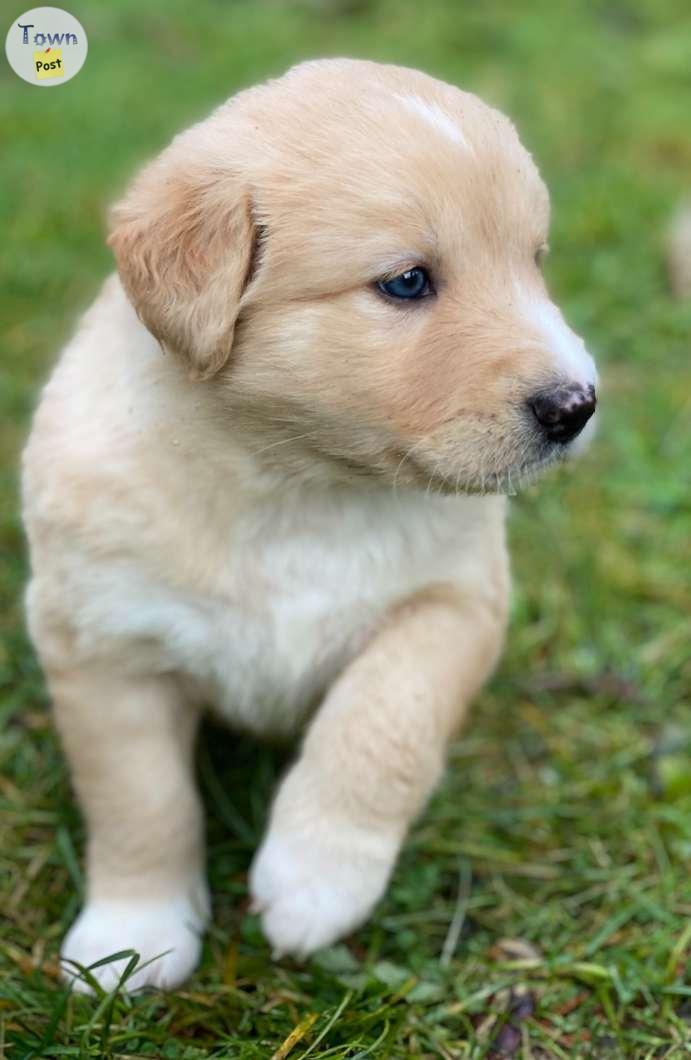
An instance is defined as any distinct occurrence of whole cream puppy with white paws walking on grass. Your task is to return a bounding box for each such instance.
[24,59,596,988]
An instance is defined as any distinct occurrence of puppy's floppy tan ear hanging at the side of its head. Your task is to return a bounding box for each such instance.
[108,152,254,378]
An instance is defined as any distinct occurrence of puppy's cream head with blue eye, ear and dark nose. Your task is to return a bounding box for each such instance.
[111,60,596,491]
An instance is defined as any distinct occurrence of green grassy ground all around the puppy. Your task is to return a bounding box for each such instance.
[0,0,691,1060]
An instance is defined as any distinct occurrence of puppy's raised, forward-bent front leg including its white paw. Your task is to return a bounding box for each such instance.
[251,587,504,955]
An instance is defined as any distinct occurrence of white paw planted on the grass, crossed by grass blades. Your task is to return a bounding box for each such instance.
[60,898,206,993]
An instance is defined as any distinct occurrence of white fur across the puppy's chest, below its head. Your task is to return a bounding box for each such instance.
[52,489,503,735]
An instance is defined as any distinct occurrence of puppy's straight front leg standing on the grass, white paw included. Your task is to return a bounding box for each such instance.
[48,668,208,990]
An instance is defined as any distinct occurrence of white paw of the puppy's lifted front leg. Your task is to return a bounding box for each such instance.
[250,820,398,957]
